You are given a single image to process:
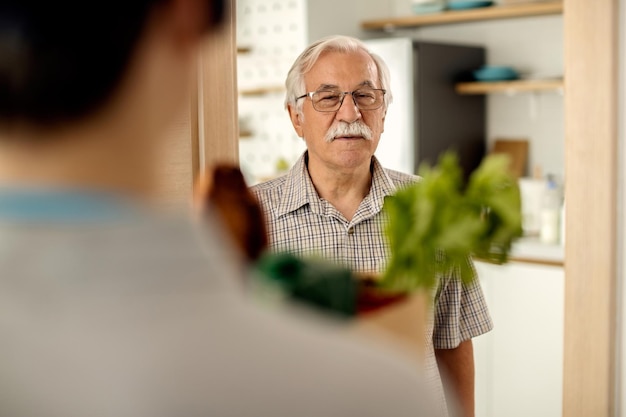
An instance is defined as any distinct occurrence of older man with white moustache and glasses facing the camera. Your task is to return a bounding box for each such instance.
[253,36,492,416]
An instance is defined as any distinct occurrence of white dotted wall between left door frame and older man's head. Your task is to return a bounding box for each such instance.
[237,0,307,184]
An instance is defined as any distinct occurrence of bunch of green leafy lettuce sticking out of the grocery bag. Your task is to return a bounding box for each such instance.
[380,153,522,292]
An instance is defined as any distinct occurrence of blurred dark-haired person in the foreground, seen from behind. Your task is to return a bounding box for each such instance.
[0,0,432,417]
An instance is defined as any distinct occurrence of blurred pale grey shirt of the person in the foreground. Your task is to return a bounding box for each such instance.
[0,191,433,417]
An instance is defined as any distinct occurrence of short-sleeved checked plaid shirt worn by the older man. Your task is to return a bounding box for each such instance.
[252,153,493,414]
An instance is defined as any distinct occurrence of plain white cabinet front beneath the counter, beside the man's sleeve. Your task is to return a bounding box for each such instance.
[474,263,565,417]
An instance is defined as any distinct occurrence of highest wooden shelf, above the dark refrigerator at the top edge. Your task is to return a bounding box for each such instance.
[361,1,563,30]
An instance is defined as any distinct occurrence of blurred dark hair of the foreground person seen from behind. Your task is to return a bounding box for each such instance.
[0,0,224,125]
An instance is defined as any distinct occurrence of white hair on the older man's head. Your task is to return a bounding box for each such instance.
[285,35,393,113]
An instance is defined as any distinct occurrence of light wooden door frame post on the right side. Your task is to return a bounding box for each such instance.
[563,0,619,417]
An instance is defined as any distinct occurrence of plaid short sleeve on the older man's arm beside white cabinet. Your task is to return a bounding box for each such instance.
[433,260,493,349]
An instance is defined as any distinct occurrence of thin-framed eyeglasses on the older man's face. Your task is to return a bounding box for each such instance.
[296,88,387,112]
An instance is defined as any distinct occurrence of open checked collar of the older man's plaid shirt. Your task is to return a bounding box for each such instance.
[277,151,397,217]
